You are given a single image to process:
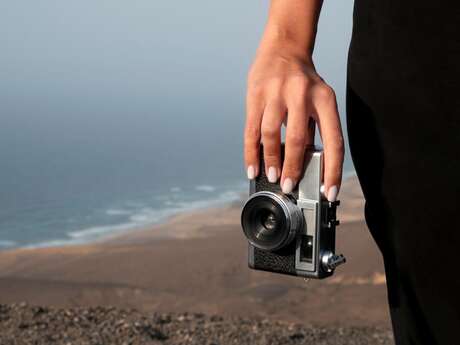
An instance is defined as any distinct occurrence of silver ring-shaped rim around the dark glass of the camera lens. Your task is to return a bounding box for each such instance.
[241,191,303,251]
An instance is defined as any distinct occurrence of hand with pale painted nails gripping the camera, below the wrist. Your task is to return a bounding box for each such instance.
[244,47,344,201]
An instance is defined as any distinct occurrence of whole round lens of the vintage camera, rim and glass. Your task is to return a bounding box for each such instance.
[241,192,303,250]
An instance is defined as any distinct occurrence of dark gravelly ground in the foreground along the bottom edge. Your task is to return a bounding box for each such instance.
[0,303,393,345]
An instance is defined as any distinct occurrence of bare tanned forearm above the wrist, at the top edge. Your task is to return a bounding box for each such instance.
[259,0,322,59]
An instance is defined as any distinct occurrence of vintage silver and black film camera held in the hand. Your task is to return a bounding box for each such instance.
[241,145,345,279]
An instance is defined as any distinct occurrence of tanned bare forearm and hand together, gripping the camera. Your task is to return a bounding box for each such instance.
[244,0,344,201]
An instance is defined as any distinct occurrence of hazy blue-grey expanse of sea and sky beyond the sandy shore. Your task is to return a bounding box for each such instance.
[0,0,353,250]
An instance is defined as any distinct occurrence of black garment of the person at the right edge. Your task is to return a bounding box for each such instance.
[347,0,460,345]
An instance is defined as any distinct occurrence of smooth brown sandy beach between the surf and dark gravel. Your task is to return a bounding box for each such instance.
[0,177,390,344]
